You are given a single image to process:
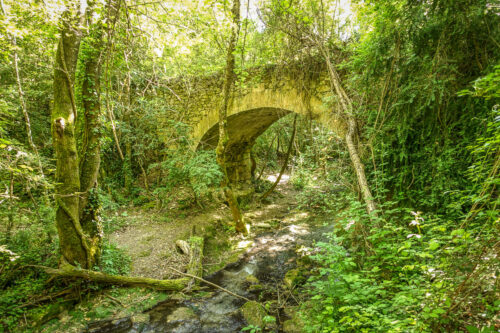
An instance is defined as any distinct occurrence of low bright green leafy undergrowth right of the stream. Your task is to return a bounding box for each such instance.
[303,192,499,332]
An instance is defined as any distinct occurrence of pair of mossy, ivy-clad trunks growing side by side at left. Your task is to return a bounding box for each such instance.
[51,0,120,269]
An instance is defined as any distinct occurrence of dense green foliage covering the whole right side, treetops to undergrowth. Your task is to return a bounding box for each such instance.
[294,0,500,332]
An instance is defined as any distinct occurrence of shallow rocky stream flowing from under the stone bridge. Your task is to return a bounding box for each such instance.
[85,211,332,333]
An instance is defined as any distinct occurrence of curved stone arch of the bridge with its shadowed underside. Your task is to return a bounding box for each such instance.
[193,82,345,184]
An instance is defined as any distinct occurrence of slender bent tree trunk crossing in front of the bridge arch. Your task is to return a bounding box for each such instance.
[216,0,246,233]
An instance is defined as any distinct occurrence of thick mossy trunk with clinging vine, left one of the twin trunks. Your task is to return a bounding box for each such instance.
[51,1,96,268]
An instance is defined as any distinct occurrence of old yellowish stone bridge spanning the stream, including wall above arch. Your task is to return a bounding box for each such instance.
[158,62,345,183]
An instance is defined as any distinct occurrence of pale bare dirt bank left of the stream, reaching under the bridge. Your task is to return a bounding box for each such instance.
[110,175,297,279]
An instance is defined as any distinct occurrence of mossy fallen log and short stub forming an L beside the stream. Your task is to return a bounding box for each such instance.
[42,236,203,291]
